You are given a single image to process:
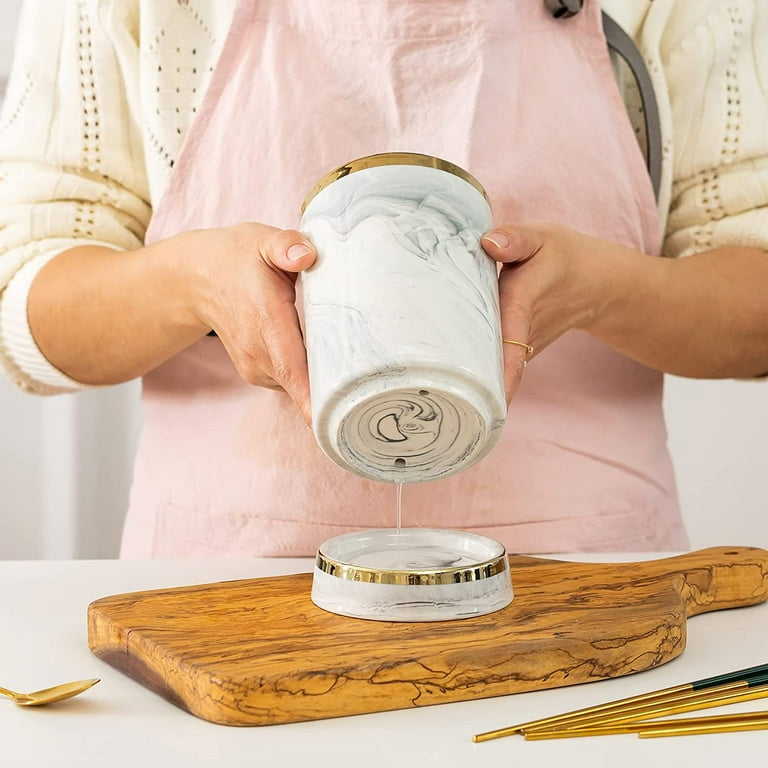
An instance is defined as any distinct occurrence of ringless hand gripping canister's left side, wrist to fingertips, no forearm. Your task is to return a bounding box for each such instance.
[176,223,317,422]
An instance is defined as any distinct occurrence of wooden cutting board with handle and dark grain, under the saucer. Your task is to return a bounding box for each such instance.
[88,547,768,725]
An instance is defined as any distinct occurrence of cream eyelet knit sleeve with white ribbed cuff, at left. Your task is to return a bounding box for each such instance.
[0,0,151,394]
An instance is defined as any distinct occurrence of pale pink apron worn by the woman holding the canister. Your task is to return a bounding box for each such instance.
[122,0,687,557]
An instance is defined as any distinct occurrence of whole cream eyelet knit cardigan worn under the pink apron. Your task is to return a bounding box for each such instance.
[0,0,768,394]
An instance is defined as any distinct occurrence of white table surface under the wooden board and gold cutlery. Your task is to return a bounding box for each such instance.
[0,555,768,768]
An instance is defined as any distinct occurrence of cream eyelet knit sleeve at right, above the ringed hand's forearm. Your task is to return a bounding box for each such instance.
[645,0,768,256]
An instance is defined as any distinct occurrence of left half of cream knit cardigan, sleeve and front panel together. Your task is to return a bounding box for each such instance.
[0,0,230,394]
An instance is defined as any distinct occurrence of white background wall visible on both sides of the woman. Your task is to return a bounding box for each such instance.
[0,0,768,559]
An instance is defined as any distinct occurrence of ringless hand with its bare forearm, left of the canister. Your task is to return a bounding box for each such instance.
[28,224,316,422]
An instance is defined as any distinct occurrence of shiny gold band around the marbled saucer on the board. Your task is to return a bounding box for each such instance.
[315,552,509,586]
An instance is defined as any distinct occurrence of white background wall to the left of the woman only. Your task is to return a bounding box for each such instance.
[0,0,140,559]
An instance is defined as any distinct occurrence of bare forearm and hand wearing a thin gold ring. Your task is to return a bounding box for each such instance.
[482,223,768,392]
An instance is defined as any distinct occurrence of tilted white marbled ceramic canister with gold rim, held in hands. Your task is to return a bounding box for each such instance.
[301,153,507,483]
